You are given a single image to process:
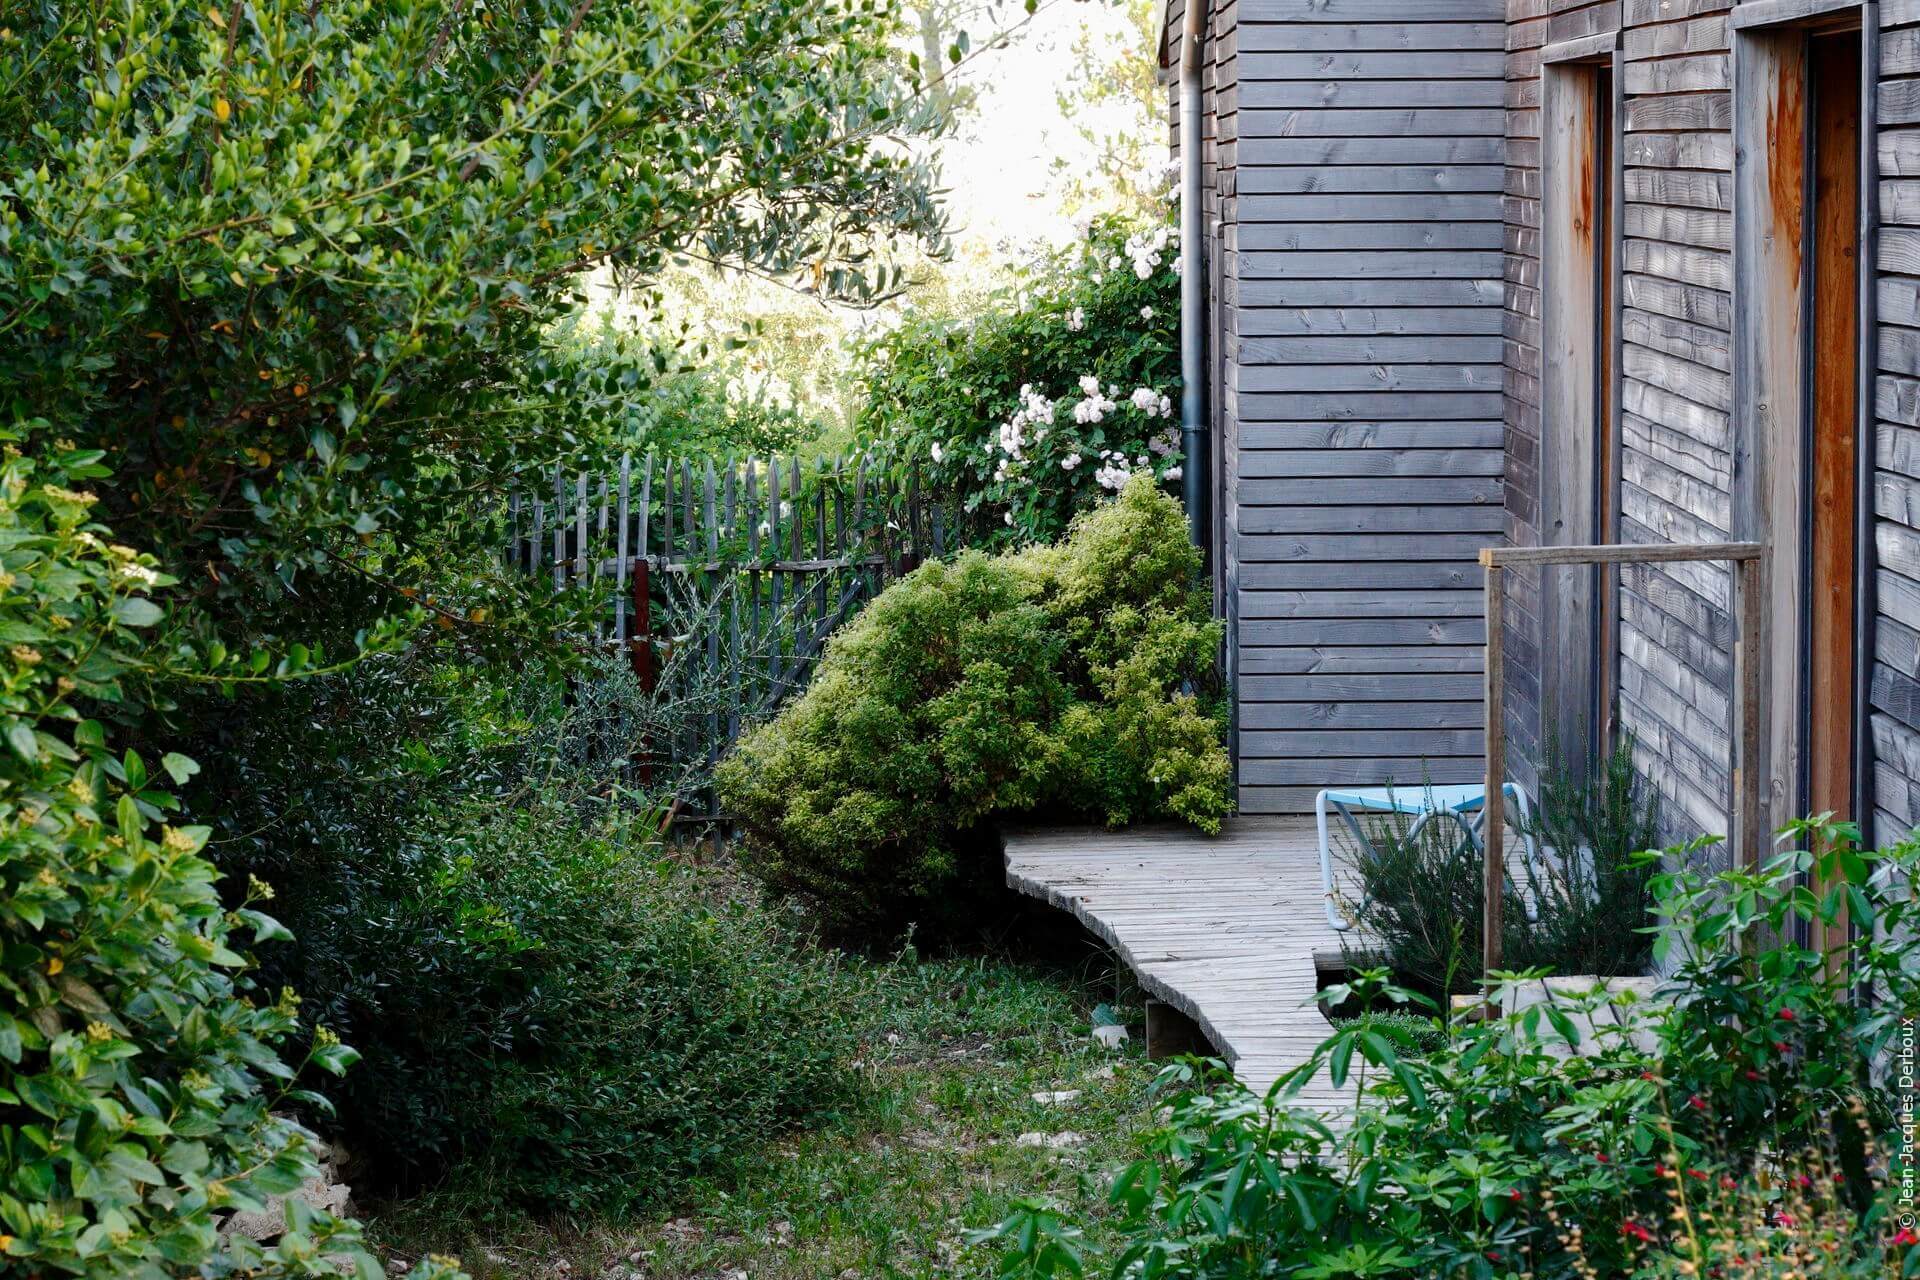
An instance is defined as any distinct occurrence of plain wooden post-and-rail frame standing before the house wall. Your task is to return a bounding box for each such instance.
[1480,543,1766,975]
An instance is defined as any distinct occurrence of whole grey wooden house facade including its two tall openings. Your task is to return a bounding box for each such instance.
[1164,0,1920,841]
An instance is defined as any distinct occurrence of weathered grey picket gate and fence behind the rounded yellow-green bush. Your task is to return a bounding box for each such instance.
[507,455,973,818]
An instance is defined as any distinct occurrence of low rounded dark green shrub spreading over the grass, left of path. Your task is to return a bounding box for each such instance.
[301,806,852,1211]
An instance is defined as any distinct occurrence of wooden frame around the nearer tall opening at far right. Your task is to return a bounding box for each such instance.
[1732,10,1880,841]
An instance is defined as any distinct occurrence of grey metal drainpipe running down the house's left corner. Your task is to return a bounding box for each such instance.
[1181,0,1210,557]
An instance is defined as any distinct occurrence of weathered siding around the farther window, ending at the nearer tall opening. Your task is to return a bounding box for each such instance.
[1505,0,1732,835]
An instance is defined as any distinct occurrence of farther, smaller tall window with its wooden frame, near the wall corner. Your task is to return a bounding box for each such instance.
[1540,42,1624,773]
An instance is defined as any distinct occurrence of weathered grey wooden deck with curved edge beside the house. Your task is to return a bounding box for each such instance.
[1006,818,1352,1111]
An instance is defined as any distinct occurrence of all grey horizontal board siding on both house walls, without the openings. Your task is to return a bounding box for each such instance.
[1169,0,1920,841]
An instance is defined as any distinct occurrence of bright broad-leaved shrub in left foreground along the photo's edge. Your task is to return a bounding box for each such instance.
[0,445,442,1280]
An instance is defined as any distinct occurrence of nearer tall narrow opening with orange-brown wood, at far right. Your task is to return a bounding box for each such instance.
[1732,13,1870,852]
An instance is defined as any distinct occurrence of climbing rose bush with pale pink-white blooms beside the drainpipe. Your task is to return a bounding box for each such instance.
[862,219,1183,545]
